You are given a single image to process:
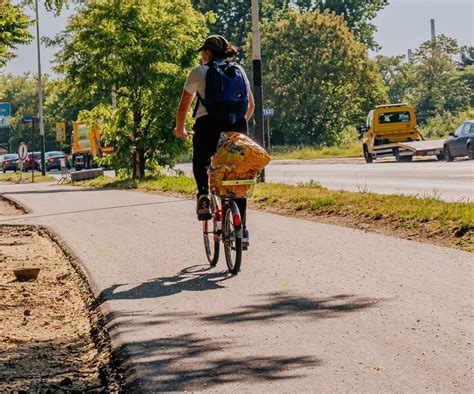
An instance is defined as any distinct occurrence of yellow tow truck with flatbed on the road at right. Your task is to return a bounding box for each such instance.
[362,103,445,163]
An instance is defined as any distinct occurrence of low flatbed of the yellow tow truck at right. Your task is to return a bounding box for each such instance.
[372,139,445,161]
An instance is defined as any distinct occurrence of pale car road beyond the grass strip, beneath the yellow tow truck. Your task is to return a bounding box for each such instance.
[179,159,474,201]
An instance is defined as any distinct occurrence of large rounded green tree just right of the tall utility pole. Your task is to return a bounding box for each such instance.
[262,11,385,145]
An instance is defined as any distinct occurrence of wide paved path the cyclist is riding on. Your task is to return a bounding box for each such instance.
[0,184,474,393]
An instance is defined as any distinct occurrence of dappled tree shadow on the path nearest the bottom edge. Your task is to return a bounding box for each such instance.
[119,333,322,392]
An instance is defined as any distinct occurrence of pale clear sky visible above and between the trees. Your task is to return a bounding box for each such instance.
[2,0,474,76]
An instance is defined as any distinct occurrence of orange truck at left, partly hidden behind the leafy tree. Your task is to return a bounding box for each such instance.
[71,121,114,171]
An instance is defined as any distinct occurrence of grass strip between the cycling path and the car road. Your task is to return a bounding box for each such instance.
[76,174,474,251]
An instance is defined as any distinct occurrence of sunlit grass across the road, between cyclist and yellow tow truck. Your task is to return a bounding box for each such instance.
[271,142,362,160]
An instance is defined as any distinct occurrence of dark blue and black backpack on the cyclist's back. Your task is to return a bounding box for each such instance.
[195,62,249,124]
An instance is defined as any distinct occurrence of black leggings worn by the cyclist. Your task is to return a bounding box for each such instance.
[193,115,248,228]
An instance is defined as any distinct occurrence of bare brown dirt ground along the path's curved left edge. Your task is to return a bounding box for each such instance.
[0,199,120,392]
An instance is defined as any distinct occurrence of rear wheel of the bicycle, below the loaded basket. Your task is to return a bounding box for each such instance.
[223,200,242,275]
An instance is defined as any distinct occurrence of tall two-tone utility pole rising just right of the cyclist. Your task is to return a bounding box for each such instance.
[252,0,265,182]
